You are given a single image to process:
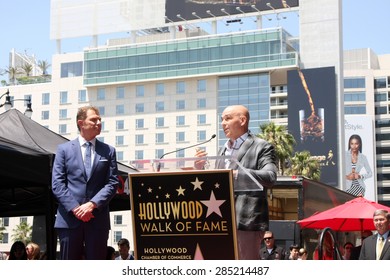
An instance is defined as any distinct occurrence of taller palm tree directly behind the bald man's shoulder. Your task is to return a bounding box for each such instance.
[257,122,296,175]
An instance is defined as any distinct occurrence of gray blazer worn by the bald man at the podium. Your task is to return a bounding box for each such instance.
[218,133,277,231]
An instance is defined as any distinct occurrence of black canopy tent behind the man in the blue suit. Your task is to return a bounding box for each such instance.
[0,109,134,257]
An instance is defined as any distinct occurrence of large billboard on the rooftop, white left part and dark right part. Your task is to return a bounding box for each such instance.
[50,0,298,40]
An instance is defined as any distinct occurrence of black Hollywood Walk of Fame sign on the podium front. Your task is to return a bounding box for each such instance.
[129,170,238,260]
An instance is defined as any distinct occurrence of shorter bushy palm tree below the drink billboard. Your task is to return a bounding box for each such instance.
[287,151,321,181]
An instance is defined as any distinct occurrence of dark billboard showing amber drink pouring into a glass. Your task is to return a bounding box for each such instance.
[287,66,339,187]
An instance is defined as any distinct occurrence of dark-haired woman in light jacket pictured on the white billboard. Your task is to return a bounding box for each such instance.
[345,134,372,196]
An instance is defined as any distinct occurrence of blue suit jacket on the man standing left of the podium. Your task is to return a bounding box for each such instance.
[52,139,119,230]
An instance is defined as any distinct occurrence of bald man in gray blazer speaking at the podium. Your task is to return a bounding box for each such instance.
[196,105,277,260]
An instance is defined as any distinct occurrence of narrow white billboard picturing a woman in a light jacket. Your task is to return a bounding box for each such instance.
[344,115,377,201]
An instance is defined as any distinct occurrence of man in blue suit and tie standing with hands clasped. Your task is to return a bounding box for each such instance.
[52,106,119,260]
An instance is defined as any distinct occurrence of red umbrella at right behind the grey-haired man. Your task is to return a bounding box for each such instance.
[297,196,390,231]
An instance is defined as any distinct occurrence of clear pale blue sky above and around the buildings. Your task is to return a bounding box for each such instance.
[0,0,390,75]
